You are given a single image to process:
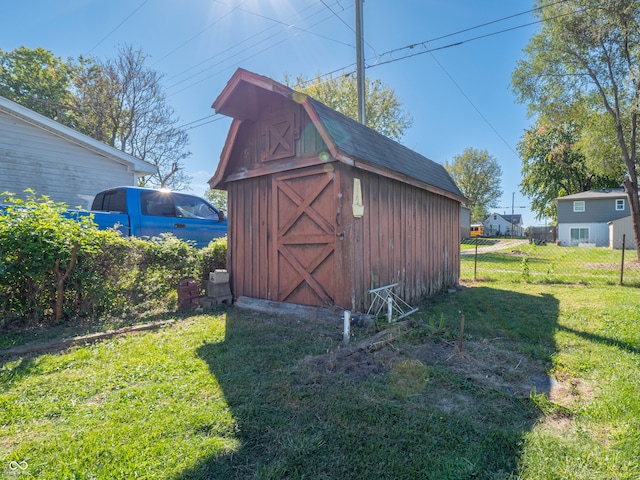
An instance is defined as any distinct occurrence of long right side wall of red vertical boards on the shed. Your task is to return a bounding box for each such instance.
[348,170,460,311]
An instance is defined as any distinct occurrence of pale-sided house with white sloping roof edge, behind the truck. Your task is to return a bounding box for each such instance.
[0,97,157,208]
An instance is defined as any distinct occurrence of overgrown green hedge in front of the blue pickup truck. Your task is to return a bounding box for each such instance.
[0,191,227,326]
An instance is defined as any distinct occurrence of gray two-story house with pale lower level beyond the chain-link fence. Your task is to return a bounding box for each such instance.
[555,188,633,247]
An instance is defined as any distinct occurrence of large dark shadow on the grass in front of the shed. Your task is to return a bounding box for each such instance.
[177,287,558,480]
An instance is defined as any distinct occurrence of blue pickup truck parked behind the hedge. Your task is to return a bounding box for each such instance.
[78,187,227,248]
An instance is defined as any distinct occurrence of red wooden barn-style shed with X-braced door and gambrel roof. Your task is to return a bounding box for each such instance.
[209,69,466,311]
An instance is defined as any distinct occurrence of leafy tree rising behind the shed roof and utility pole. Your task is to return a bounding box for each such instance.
[285,75,413,141]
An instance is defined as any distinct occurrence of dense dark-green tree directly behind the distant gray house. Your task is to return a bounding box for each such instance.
[518,120,621,220]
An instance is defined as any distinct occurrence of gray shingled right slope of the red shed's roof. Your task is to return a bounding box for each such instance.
[309,98,464,201]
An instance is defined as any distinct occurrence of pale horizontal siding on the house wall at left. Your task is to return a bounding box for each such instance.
[0,112,136,208]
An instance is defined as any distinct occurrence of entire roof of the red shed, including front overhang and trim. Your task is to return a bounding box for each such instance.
[209,69,466,203]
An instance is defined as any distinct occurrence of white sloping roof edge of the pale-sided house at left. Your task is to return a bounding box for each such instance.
[0,96,158,175]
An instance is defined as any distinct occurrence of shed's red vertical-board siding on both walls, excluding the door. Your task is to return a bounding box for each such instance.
[227,117,460,311]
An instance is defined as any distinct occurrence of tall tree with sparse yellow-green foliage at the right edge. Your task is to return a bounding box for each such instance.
[512,0,640,258]
